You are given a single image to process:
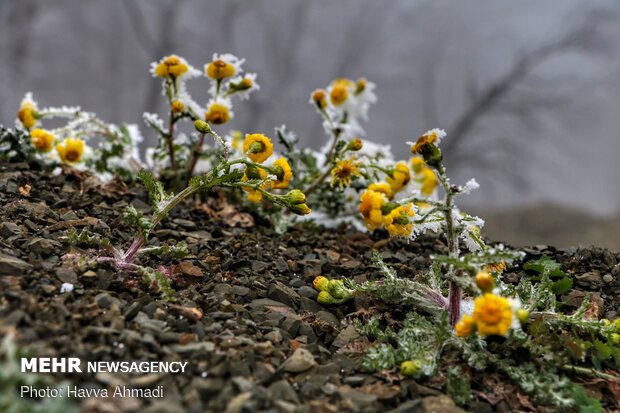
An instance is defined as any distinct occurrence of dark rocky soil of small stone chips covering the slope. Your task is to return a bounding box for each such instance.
[0,165,620,413]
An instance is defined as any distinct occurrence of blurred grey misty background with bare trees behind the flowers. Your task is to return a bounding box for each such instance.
[0,0,620,250]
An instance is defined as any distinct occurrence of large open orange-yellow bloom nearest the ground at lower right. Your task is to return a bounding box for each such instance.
[473,293,512,336]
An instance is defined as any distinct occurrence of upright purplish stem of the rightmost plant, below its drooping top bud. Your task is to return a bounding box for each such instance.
[437,166,463,326]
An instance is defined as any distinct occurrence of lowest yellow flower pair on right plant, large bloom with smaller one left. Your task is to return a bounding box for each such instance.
[454,293,513,337]
